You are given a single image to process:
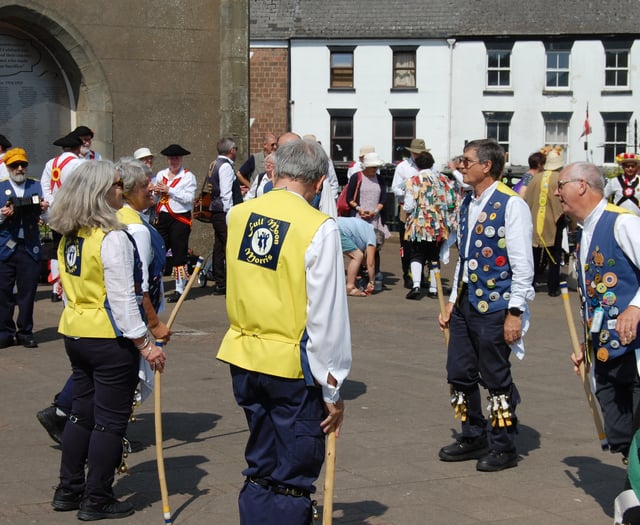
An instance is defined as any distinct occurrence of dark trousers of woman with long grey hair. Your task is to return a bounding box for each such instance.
[60,337,139,503]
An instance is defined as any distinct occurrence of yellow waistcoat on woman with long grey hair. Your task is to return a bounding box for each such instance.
[58,228,117,338]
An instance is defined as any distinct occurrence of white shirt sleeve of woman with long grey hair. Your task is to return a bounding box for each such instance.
[100,231,147,339]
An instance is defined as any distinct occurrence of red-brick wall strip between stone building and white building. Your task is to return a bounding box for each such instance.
[246,48,289,156]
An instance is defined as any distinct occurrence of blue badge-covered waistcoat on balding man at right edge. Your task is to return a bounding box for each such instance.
[576,204,640,362]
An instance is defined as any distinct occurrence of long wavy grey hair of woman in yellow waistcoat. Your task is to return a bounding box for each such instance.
[49,160,126,236]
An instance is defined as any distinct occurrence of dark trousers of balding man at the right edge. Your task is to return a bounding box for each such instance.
[594,352,640,456]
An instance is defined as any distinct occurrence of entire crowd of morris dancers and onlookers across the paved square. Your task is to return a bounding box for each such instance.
[0,126,640,524]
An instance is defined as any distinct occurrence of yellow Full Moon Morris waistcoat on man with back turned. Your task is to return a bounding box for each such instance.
[217,190,329,379]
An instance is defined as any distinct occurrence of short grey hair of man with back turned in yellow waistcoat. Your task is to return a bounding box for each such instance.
[274,140,329,184]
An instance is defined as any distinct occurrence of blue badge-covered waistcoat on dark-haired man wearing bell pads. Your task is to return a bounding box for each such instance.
[459,182,517,314]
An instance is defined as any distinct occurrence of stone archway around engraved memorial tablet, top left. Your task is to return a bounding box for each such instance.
[0,1,113,177]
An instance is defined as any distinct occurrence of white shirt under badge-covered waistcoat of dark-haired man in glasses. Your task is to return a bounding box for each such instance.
[449,181,535,311]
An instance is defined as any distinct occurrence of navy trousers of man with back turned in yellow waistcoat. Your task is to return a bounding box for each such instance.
[231,366,325,525]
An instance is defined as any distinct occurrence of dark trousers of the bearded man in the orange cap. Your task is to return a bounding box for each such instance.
[0,242,40,340]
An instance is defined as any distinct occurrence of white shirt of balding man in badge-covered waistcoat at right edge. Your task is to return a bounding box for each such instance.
[579,199,640,308]
